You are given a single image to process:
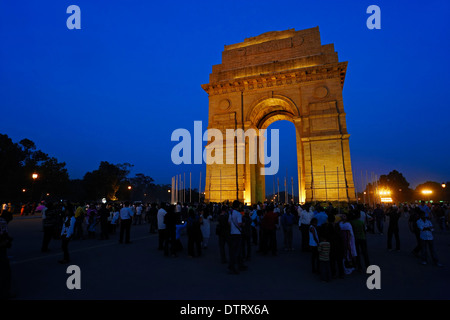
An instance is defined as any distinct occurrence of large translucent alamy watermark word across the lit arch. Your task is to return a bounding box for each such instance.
[171,121,280,175]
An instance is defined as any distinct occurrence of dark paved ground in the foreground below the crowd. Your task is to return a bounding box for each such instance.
[4,211,450,301]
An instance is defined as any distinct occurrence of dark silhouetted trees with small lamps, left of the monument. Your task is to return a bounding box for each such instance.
[0,134,170,203]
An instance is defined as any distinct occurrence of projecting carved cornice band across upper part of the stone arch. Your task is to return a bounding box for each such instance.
[202,61,347,96]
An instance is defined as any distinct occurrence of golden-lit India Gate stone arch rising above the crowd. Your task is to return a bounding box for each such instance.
[202,27,355,204]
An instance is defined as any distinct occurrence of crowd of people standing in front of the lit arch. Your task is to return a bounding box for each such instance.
[0,200,450,298]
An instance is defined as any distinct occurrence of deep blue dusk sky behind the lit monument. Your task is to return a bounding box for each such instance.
[0,0,450,193]
